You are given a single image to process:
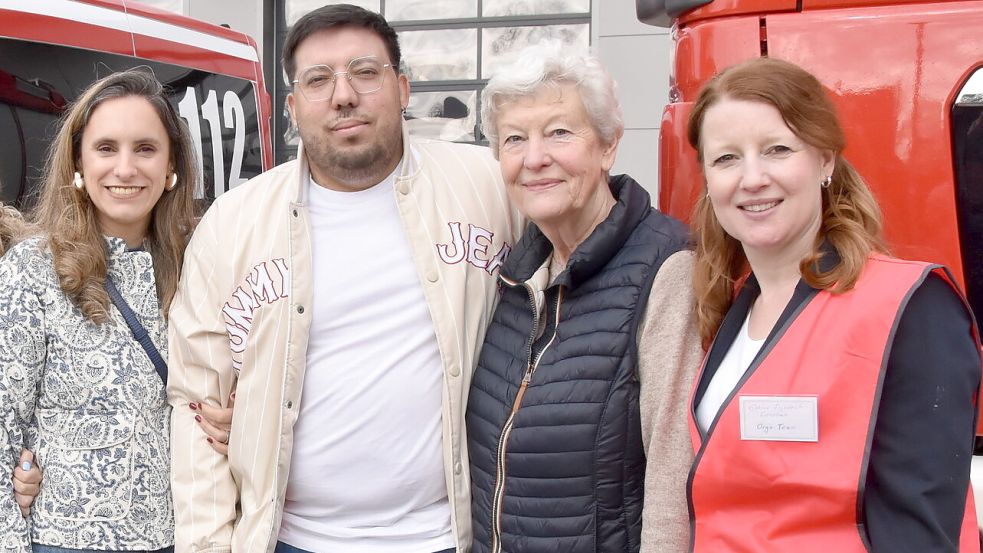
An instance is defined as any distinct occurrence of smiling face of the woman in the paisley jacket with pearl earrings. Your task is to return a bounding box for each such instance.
[79,96,171,246]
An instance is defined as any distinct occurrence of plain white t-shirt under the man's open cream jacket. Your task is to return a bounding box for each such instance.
[279,167,454,553]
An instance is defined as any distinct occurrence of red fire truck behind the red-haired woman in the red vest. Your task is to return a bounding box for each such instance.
[635,0,983,521]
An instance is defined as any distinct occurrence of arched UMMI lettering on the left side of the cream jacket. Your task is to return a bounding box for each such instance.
[222,258,290,373]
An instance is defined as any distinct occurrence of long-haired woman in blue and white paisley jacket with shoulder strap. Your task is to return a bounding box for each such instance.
[0,71,198,553]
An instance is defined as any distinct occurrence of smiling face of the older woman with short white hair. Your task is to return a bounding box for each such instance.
[497,84,618,234]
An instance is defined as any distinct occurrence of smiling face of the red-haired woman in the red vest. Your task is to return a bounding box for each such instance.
[700,98,834,263]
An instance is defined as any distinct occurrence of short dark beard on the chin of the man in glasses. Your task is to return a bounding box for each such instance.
[299,117,402,186]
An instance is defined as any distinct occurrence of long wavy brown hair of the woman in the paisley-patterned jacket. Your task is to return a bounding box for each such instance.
[32,70,199,323]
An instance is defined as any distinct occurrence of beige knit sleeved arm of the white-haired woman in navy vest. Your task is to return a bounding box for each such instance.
[638,251,703,553]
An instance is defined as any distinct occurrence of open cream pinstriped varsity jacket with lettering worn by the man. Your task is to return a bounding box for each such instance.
[168,133,523,553]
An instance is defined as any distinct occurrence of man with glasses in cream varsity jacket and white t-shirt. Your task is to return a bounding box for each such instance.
[169,5,522,553]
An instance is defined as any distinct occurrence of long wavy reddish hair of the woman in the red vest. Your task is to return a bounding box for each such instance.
[687,58,887,347]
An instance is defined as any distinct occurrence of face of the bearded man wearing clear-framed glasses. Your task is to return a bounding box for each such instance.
[287,27,410,191]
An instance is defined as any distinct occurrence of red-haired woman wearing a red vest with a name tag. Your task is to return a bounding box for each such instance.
[688,58,980,552]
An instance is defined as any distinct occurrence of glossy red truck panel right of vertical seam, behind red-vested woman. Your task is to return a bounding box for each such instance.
[768,2,983,281]
